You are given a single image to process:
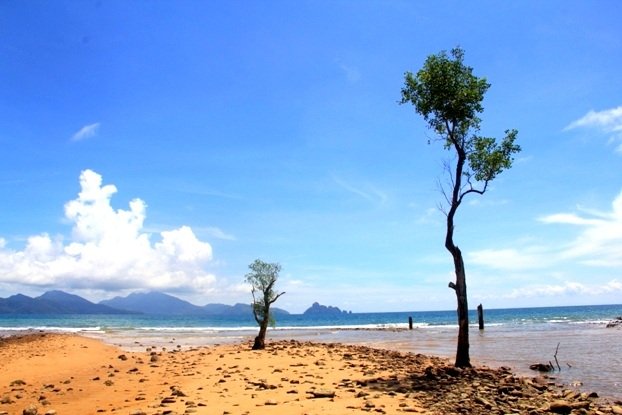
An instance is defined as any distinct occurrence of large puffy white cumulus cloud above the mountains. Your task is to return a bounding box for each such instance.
[0,170,215,291]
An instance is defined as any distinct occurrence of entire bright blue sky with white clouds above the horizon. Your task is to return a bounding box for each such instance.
[0,0,622,312]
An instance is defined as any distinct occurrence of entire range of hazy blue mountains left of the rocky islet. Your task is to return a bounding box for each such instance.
[0,291,289,317]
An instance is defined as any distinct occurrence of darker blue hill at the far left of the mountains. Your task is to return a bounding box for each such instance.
[0,291,132,314]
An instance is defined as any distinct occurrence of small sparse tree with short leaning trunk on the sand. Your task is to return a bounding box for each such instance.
[245,259,285,350]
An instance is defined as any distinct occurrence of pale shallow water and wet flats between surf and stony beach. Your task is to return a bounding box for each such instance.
[6,325,622,401]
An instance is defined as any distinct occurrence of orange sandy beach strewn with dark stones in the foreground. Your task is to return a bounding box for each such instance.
[0,333,622,415]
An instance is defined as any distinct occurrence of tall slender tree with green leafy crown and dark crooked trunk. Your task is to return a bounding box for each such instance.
[401,48,520,367]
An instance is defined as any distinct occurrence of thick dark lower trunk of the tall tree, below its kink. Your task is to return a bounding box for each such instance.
[452,246,471,367]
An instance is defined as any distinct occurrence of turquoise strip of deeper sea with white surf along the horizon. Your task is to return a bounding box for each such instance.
[0,305,622,333]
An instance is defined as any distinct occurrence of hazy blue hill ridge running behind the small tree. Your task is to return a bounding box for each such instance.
[100,291,289,317]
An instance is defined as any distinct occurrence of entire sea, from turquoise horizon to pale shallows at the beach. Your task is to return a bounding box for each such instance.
[0,304,622,401]
